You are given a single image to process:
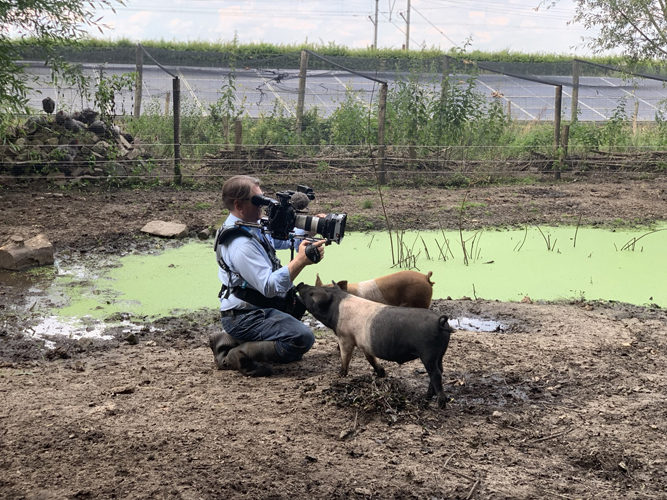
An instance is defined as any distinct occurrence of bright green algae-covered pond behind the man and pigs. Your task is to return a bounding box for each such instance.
[45,224,667,319]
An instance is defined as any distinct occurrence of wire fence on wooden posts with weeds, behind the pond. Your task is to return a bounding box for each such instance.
[0,46,667,184]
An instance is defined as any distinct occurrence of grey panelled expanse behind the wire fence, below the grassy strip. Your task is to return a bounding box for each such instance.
[19,47,667,122]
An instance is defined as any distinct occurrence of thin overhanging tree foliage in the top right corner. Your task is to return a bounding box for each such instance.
[542,0,667,61]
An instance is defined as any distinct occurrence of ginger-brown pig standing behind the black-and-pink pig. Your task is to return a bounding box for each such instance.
[315,271,434,309]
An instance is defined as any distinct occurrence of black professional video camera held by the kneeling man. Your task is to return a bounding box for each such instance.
[251,186,347,244]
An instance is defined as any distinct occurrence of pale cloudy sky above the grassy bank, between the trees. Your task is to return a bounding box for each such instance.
[94,0,604,56]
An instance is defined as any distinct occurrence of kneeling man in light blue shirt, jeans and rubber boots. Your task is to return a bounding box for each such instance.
[209,175,324,377]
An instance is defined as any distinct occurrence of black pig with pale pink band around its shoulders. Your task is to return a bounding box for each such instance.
[296,283,453,408]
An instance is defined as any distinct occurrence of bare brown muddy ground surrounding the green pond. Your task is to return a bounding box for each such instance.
[0,176,667,500]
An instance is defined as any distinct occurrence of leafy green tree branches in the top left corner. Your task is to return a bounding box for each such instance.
[0,0,122,113]
